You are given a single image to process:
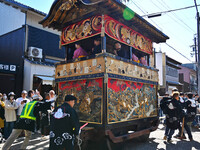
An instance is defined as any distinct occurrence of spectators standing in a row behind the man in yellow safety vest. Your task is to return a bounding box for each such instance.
[0,90,56,140]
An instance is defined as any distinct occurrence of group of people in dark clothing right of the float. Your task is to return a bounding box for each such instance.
[160,89,200,142]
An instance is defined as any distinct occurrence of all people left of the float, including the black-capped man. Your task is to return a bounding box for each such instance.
[0,90,80,150]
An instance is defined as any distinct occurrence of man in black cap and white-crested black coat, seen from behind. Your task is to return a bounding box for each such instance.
[49,95,80,150]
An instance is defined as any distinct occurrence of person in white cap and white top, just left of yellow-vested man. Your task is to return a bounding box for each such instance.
[16,90,30,118]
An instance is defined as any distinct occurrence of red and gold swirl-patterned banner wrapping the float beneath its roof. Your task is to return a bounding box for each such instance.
[61,15,153,54]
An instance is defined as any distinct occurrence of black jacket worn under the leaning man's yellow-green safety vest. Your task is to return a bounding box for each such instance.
[14,101,51,132]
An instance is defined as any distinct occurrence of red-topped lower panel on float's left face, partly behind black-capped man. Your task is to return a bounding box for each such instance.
[58,78,103,124]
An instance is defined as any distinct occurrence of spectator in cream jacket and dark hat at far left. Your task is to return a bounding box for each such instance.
[4,92,18,139]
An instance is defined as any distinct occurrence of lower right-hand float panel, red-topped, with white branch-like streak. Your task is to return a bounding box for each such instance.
[107,78,157,124]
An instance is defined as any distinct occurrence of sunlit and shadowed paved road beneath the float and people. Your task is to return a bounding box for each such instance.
[0,124,200,150]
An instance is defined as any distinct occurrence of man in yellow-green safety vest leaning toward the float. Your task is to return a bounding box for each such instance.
[2,96,54,150]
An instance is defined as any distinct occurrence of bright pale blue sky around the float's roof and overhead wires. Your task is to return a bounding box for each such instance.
[16,0,200,63]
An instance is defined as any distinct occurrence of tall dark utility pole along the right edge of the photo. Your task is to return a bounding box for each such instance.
[194,0,200,95]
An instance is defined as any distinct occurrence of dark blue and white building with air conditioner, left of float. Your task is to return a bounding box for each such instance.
[0,0,65,95]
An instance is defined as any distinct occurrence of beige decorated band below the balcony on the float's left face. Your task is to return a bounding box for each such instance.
[55,57,105,78]
